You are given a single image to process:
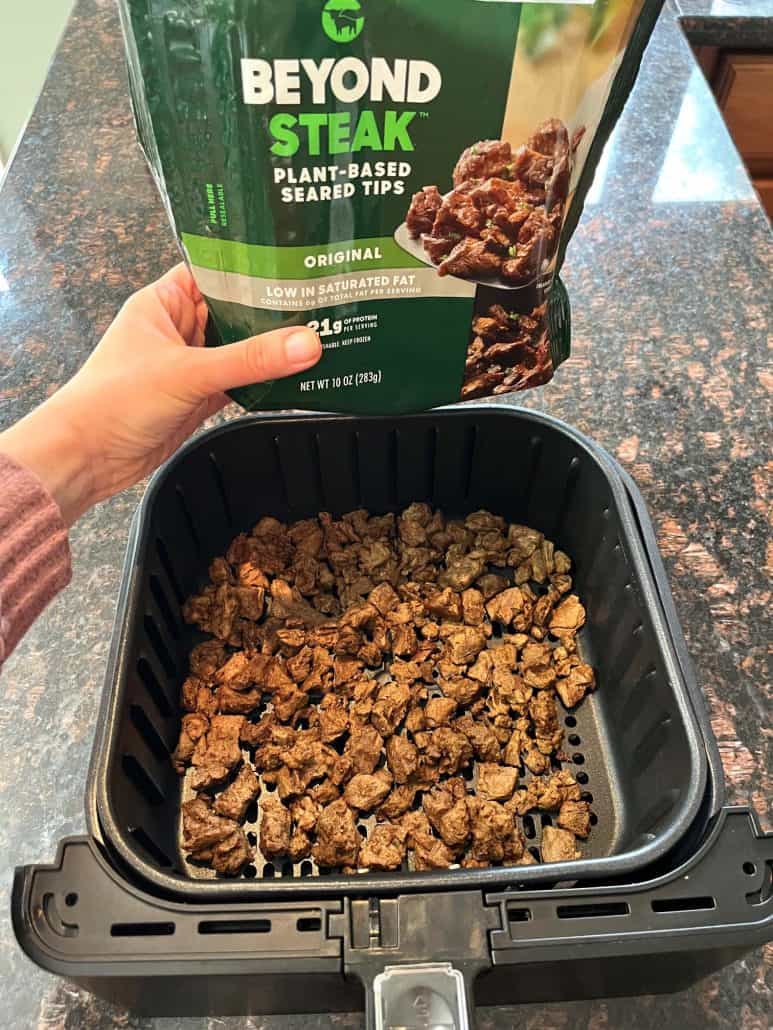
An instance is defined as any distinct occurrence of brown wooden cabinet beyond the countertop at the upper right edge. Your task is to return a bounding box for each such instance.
[696,46,773,218]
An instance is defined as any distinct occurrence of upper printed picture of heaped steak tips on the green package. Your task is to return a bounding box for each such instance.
[405,118,579,285]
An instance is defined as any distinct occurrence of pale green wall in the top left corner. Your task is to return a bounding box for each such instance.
[0,0,72,161]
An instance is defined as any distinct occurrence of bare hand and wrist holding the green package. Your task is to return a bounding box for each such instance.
[0,265,322,525]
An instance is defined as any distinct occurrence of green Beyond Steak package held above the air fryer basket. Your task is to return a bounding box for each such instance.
[119,0,662,414]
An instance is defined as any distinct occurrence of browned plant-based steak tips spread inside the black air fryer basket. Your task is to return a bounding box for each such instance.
[177,502,596,876]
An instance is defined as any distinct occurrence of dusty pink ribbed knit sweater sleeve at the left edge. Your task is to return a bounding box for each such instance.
[0,454,71,666]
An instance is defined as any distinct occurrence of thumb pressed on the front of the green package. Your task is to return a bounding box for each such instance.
[189,325,322,397]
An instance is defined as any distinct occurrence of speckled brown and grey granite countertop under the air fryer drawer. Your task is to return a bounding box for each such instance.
[0,0,773,1030]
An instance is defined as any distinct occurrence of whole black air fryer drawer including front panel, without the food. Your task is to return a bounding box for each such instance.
[13,406,773,1027]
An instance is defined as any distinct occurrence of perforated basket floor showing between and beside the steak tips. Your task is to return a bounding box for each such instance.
[177,633,620,880]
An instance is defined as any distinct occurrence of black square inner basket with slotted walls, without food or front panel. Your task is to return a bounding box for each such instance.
[92,406,706,900]
